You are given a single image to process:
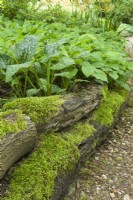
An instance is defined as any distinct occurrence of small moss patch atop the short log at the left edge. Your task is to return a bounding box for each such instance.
[0,110,27,140]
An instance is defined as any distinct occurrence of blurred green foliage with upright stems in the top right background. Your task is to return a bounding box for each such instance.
[78,0,133,31]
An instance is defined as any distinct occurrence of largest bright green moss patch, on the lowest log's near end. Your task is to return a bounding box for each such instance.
[5,122,94,200]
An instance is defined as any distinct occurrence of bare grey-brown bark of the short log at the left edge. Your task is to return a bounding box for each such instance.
[0,115,37,179]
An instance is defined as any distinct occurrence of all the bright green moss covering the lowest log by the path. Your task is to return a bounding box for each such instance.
[2,88,126,200]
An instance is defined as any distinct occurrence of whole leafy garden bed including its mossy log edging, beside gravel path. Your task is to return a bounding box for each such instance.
[0,1,133,200]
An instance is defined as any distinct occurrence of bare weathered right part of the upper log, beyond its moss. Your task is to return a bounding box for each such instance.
[36,85,103,133]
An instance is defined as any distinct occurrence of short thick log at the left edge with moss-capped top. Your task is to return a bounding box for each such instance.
[0,111,37,179]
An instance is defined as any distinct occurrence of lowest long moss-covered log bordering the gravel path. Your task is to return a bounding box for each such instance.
[0,88,127,200]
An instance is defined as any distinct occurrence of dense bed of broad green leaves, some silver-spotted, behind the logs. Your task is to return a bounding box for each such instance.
[0,21,132,97]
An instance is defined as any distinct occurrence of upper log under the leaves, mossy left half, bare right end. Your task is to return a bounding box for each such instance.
[3,85,103,133]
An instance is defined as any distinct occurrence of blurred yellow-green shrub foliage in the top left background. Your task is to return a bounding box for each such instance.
[0,0,69,23]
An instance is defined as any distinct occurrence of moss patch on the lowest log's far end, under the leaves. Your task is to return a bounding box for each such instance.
[91,87,127,126]
